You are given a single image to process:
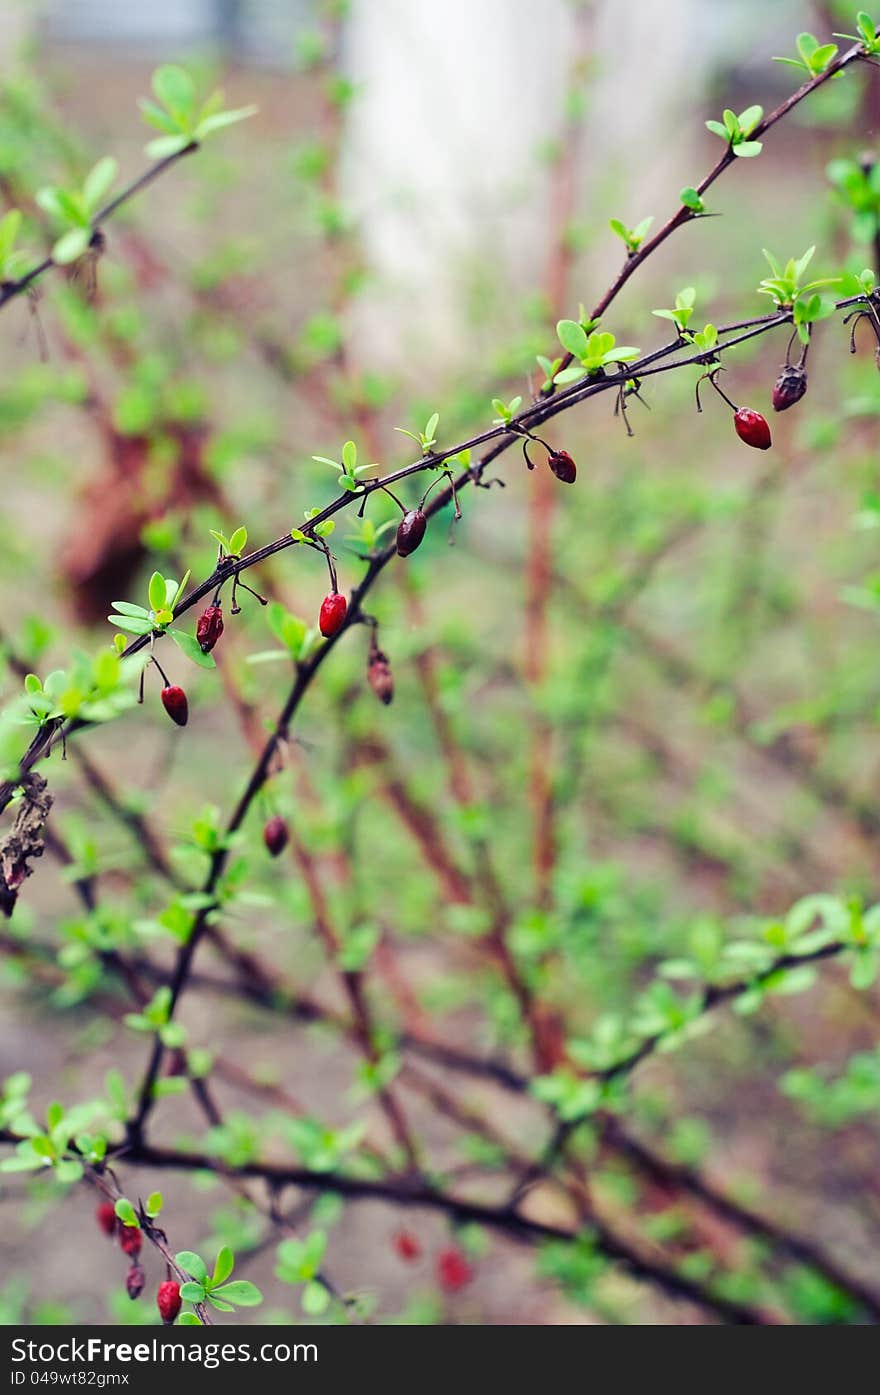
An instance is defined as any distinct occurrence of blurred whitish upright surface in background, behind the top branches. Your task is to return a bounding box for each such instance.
[343,0,718,367]
